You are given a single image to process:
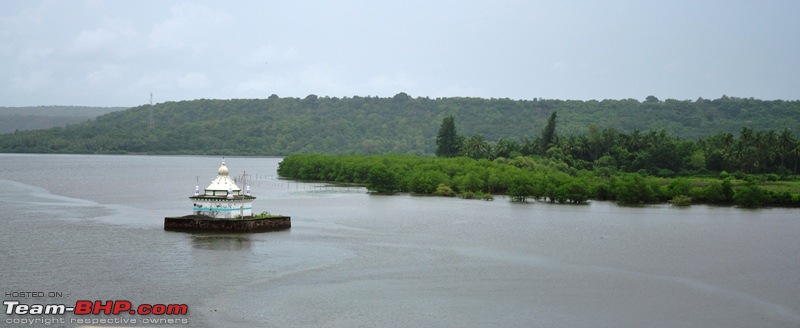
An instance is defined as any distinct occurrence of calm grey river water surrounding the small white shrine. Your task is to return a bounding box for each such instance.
[0,154,800,328]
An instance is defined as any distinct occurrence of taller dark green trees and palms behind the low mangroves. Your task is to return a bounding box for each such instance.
[436,112,800,177]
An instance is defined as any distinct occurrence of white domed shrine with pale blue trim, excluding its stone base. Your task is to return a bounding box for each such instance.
[189,159,256,219]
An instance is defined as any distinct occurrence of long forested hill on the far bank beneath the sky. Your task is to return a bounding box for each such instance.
[0,93,800,155]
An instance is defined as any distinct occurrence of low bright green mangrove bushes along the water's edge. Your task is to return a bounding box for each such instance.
[278,154,800,207]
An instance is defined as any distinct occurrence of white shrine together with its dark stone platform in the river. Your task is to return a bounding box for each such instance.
[164,160,292,232]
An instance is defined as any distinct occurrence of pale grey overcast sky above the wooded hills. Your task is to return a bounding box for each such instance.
[0,0,800,106]
